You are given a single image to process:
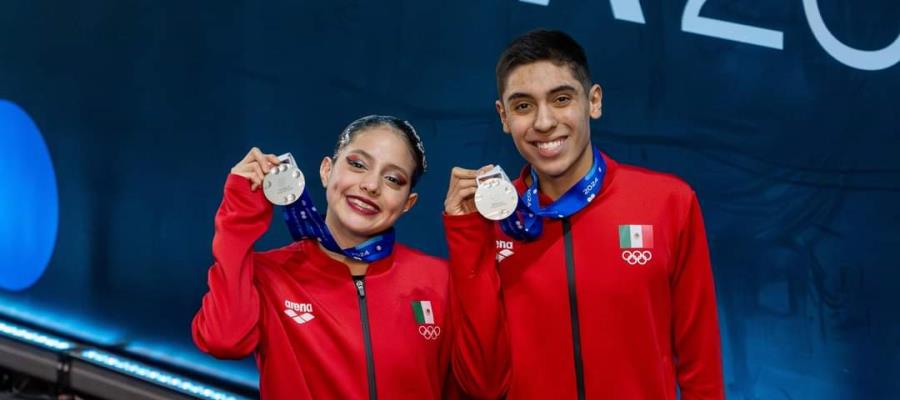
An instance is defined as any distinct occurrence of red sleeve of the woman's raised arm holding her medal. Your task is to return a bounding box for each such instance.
[192,174,272,358]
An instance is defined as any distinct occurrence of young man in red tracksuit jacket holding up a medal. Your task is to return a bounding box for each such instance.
[444,31,724,400]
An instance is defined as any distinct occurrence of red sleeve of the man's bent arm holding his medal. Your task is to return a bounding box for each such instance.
[444,213,511,398]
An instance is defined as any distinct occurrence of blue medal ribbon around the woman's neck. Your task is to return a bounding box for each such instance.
[284,190,395,263]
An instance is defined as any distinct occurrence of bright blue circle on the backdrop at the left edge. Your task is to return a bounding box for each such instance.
[0,99,59,290]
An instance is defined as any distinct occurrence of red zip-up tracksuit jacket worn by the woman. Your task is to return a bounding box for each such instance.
[193,175,452,400]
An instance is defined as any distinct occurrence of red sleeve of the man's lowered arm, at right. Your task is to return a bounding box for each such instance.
[671,192,725,400]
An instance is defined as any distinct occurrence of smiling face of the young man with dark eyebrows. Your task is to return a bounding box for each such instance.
[496,61,602,183]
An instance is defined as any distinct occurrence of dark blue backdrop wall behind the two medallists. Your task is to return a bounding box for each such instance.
[0,0,900,399]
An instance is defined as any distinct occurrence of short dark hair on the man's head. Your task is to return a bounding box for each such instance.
[496,29,592,100]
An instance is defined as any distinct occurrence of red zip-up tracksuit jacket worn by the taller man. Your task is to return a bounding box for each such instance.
[444,155,724,400]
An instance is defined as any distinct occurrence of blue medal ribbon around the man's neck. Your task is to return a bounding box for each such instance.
[500,146,606,241]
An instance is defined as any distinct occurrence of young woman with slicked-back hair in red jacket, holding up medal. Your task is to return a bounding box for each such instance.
[193,116,452,399]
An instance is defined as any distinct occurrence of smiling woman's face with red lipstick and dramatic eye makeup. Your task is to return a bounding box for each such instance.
[319,126,417,247]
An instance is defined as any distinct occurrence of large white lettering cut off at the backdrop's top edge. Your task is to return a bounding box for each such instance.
[520,0,900,71]
